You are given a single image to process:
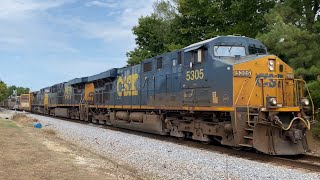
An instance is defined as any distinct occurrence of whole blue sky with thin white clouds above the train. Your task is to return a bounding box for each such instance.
[0,0,155,91]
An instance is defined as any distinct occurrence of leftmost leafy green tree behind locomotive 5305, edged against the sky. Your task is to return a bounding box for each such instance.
[127,0,179,65]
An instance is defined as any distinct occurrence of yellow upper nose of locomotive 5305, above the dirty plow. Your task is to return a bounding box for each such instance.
[234,55,295,108]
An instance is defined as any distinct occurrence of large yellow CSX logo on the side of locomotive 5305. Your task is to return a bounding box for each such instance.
[117,74,139,96]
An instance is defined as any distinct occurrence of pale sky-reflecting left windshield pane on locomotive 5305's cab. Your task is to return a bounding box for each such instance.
[213,46,246,57]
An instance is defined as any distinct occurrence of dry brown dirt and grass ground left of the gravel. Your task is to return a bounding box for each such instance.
[0,113,143,180]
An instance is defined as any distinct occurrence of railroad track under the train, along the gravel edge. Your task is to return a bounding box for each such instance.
[26,114,320,172]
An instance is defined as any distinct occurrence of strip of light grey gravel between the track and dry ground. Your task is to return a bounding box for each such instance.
[29,115,320,179]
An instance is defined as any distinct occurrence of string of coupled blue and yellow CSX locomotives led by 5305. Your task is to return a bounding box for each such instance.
[25,36,315,155]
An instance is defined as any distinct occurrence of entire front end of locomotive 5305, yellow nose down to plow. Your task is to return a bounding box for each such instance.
[233,55,313,155]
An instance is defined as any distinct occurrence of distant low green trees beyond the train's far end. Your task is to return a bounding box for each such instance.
[0,80,30,102]
